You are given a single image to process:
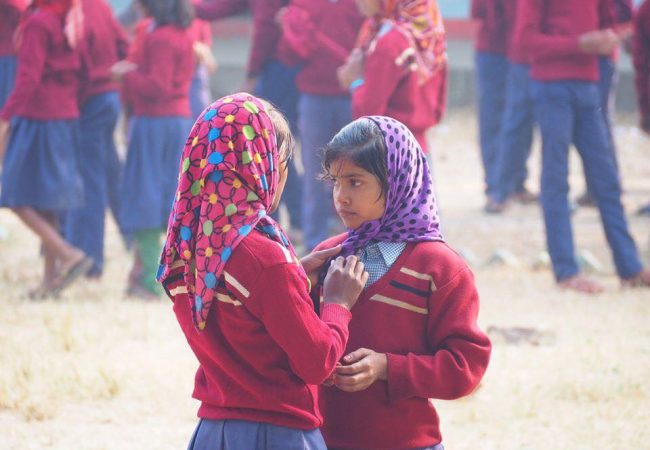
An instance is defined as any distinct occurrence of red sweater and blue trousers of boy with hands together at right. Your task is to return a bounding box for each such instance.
[515,0,642,281]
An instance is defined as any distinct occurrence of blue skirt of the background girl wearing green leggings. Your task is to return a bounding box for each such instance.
[118,116,191,234]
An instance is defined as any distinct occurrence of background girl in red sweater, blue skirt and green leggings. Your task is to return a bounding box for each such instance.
[112,0,195,298]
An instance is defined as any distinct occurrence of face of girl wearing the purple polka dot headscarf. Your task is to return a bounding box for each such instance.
[330,158,386,229]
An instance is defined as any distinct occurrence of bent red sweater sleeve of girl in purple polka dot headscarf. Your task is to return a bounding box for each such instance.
[387,268,491,402]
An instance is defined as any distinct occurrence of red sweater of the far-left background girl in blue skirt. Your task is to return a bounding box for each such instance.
[0,10,81,120]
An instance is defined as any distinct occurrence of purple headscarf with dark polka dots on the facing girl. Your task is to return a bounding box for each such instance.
[342,116,443,255]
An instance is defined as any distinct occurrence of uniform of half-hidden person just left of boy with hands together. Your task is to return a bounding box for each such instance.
[492,0,535,203]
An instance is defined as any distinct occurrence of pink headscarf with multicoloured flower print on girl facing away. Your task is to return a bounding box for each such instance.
[157,93,295,330]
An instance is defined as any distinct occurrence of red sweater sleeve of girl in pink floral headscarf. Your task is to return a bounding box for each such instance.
[248,264,352,384]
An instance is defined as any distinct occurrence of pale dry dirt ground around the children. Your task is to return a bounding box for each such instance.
[0,112,650,450]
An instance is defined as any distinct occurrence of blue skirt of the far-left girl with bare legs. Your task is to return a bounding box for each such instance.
[0,117,84,212]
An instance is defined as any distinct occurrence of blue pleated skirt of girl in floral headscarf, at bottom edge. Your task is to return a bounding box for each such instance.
[187,419,327,450]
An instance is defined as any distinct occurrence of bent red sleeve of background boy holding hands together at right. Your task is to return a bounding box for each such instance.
[514,0,584,61]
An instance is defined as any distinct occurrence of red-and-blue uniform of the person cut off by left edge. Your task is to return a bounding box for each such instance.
[0,0,27,108]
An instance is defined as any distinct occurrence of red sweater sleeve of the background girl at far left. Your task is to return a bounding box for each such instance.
[0,17,49,120]
